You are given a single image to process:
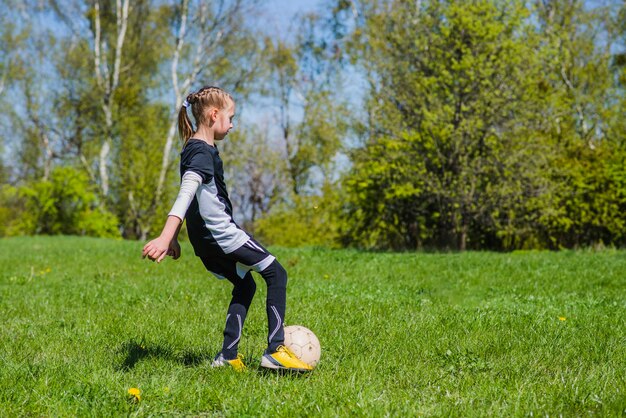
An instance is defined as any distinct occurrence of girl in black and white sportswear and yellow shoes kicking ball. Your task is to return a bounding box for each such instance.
[143,86,311,371]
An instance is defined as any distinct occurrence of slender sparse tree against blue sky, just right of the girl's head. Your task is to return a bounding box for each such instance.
[263,10,349,195]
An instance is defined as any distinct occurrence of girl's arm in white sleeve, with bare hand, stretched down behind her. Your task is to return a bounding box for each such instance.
[142,171,202,263]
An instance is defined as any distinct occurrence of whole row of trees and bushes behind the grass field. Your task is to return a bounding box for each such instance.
[0,0,626,250]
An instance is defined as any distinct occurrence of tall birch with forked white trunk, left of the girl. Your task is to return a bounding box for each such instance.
[51,0,171,237]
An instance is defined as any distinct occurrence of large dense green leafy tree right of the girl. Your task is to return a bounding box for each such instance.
[336,1,534,250]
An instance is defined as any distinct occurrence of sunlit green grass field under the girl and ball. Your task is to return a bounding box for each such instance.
[0,237,626,417]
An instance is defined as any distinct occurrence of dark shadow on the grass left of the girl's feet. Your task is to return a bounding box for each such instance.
[118,340,213,371]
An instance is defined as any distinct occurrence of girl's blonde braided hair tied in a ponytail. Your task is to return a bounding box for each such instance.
[178,86,235,145]
